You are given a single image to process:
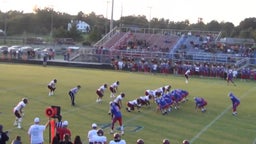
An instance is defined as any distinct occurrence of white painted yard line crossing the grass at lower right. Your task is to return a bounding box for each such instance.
[190,87,256,144]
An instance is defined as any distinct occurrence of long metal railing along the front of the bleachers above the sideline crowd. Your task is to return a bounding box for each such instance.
[71,48,256,68]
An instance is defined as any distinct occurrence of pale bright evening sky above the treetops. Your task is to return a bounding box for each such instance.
[0,0,256,26]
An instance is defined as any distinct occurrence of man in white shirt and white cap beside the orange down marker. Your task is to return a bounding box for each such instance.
[28,117,49,144]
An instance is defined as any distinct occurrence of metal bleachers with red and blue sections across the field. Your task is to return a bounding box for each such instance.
[90,27,256,70]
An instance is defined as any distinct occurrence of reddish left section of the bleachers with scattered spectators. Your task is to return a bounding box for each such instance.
[103,32,178,52]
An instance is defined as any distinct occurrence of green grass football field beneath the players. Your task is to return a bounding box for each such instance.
[0,64,256,144]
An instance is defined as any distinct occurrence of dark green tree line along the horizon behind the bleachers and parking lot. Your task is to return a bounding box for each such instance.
[0,7,256,43]
